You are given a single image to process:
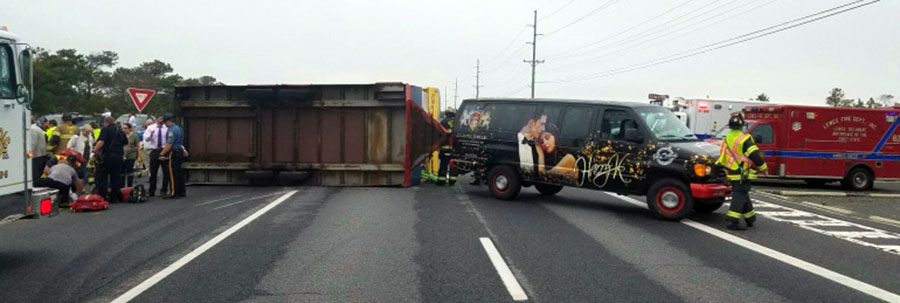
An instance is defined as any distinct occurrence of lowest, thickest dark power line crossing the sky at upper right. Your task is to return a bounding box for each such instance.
[560,0,881,82]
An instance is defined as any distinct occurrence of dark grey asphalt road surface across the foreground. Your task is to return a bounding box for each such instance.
[0,180,900,302]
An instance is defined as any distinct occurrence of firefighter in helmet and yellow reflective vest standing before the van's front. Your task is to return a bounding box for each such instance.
[716,112,768,230]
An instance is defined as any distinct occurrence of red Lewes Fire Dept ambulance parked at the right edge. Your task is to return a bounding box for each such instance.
[732,105,900,190]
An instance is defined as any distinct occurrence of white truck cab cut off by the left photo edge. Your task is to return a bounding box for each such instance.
[0,26,33,220]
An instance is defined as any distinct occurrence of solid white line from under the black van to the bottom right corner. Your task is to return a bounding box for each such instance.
[614,195,900,302]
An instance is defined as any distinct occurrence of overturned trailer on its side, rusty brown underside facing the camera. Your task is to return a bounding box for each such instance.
[175,83,447,186]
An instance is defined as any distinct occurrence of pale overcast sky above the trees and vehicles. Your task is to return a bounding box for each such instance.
[0,0,900,108]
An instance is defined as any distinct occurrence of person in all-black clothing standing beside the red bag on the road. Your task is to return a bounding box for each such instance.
[94,116,128,203]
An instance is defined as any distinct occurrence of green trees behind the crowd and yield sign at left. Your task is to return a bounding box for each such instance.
[32,48,224,116]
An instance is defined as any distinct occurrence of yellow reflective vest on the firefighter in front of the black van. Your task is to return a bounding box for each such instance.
[716,130,766,181]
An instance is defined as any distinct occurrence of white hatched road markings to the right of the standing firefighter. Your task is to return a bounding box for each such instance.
[753,199,900,255]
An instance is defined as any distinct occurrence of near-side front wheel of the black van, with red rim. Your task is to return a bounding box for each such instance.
[647,179,694,221]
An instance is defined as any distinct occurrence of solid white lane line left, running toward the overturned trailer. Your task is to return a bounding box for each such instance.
[112,190,297,303]
